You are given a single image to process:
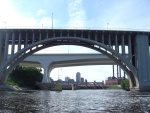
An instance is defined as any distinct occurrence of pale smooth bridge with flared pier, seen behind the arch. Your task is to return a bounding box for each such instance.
[19,54,115,83]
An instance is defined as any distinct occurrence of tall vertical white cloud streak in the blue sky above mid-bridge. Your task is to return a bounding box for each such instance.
[68,0,86,28]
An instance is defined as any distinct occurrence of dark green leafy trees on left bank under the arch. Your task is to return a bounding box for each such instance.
[7,66,43,87]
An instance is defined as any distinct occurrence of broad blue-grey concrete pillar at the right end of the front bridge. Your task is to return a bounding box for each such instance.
[135,34,150,90]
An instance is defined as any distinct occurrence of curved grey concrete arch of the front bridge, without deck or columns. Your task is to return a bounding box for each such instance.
[0,36,139,88]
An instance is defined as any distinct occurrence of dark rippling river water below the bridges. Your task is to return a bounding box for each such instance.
[0,90,150,113]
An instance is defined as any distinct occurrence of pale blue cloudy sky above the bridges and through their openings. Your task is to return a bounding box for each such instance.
[0,0,150,81]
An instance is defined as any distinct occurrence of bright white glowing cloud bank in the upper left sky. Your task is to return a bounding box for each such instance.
[0,0,52,28]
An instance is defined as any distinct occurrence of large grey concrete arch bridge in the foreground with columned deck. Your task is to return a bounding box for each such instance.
[0,29,150,90]
